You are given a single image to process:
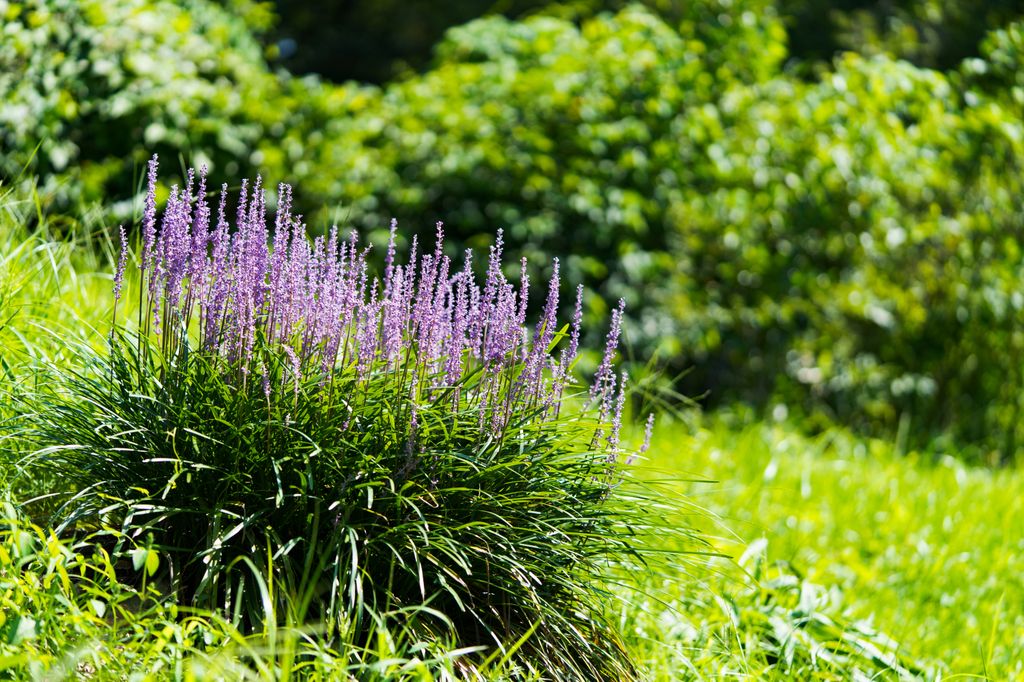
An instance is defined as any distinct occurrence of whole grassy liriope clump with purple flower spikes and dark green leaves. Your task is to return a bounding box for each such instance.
[27,159,655,679]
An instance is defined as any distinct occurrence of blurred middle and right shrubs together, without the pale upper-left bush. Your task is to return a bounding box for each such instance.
[303,5,1024,458]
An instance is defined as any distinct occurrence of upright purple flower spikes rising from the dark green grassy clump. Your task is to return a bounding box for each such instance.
[115,157,638,448]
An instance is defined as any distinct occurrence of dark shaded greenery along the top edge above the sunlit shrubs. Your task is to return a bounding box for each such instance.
[265,0,1024,83]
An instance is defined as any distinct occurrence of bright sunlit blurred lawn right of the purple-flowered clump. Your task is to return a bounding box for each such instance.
[641,419,1024,680]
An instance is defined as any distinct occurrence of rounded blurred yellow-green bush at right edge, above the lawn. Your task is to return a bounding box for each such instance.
[675,55,1024,459]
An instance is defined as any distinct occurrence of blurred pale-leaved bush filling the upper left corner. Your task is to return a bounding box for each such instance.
[0,0,286,217]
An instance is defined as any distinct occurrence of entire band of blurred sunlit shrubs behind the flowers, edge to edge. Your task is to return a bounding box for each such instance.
[6,0,1024,460]
